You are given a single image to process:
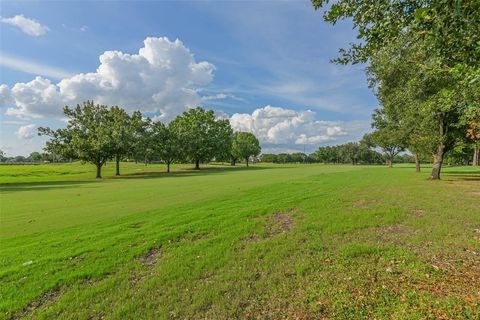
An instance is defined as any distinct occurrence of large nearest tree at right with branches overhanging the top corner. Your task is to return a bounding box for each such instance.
[313,0,480,179]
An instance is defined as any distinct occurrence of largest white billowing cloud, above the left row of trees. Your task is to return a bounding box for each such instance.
[0,37,215,120]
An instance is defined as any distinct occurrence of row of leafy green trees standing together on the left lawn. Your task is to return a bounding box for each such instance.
[39,101,261,178]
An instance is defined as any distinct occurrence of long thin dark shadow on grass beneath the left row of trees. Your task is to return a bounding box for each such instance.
[0,166,288,192]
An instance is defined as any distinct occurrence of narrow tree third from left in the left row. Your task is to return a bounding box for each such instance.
[151,122,182,172]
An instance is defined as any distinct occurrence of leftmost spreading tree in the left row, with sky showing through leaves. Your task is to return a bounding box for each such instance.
[39,101,114,178]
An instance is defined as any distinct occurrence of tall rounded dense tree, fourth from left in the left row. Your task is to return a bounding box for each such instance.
[170,107,232,169]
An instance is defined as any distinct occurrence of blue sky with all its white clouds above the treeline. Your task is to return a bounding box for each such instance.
[0,1,377,155]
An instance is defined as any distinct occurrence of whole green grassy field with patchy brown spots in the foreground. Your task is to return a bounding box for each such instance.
[0,163,480,319]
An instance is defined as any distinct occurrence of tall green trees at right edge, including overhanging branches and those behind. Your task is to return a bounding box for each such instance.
[313,0,480,179]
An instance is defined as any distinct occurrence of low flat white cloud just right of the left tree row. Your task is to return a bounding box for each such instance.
[230,105,347,145]
